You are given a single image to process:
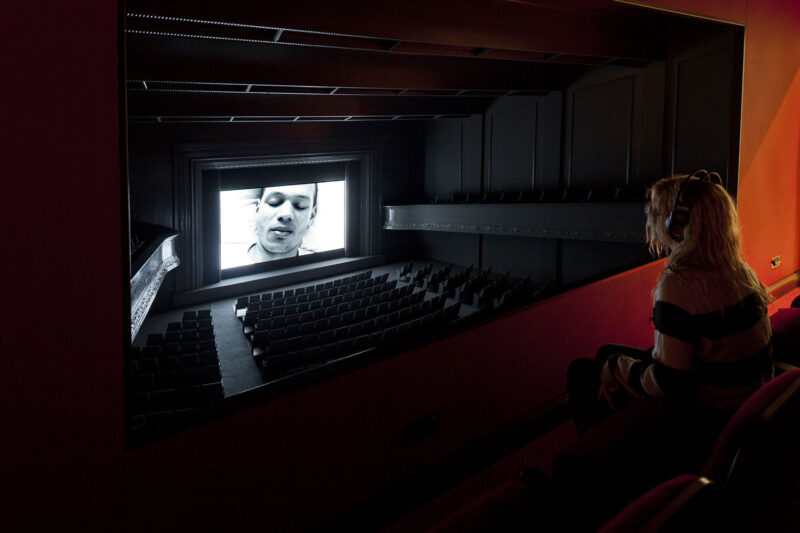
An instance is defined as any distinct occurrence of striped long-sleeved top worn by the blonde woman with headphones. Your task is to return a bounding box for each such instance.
[601,270,772,409]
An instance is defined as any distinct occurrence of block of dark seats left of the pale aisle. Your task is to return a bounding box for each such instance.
[126,309,224,438]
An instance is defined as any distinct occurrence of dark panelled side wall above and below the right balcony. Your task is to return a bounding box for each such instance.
[422,37,739,286]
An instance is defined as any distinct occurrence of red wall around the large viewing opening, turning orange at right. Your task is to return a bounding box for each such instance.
[0,0,800,531]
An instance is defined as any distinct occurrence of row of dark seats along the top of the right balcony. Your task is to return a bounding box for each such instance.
[431,186,646,204]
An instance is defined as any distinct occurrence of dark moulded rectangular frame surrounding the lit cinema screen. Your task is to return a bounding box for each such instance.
[173,138,383,294]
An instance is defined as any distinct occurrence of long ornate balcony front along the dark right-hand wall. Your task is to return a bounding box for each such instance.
[383,203,645,243]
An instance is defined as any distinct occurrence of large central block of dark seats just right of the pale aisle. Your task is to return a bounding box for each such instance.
[235,271,461,381]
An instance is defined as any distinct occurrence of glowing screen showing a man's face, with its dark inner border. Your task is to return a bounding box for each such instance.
[200,157,360,286]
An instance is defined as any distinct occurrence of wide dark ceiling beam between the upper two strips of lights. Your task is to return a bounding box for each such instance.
[127,34,583,91]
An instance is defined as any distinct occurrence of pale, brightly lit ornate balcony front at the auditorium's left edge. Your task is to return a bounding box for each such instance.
[131,235,180,340]
